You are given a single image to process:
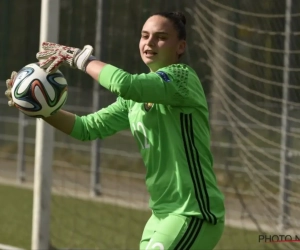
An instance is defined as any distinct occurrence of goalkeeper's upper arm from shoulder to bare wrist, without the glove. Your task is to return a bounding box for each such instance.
[86,60,200,106]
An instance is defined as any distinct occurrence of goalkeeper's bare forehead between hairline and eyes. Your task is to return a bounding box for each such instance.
[143,15,175,33]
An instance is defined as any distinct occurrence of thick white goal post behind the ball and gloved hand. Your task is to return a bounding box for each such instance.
[31,0,60,250]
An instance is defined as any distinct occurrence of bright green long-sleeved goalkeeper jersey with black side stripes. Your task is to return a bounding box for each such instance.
[71,64,225,224]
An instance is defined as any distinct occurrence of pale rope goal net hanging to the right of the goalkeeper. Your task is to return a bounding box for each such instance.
[188,0,300,249]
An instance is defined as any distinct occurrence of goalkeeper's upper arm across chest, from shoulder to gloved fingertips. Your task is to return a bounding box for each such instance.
[37,42,203,106]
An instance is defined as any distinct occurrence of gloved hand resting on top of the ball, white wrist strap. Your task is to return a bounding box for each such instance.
[36,42,95,73]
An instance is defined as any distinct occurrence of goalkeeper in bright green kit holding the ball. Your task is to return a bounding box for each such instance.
[6,12,225,250]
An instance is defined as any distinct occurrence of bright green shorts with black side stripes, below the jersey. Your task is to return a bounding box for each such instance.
[140,214,224,250]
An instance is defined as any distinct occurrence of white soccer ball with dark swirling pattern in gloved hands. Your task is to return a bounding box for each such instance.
[12,63,68,118]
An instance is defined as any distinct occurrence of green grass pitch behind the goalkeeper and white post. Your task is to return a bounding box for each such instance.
[0,185,288,250]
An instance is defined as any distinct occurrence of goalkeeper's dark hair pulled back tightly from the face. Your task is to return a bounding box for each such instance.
[153,11,186,40]
